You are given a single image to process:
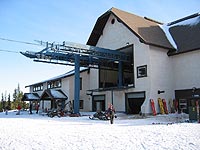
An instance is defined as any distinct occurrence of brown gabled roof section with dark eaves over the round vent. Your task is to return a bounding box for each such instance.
[87,8,174,49]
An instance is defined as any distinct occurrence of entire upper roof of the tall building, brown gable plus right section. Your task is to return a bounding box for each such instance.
[87,8,200,55]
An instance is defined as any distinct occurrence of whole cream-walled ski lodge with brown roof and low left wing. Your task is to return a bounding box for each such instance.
[23,8,200,114]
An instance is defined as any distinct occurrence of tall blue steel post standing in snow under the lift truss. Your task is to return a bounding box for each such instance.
[74,54,80,114]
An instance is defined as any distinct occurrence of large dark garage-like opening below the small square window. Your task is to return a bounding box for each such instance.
[126,92,145,114]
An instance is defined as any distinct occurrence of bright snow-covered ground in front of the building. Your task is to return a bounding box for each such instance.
[0,111,200,150]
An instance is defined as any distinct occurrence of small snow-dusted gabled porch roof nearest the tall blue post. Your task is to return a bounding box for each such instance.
[40,89,68,100]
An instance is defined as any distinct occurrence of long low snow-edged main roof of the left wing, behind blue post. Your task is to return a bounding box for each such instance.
[26,67,89,87]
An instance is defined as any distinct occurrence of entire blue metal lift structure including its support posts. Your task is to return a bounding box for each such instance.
[20,41,131,114]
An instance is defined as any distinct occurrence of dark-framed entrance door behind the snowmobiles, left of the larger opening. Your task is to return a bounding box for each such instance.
[92,95,105,111]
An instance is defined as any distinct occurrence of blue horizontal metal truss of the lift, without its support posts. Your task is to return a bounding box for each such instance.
[20,42,131,69]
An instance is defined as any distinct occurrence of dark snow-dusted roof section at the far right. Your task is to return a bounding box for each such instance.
[168,13,200,54]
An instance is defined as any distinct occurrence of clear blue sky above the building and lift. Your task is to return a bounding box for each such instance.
[0,0,200,98]
